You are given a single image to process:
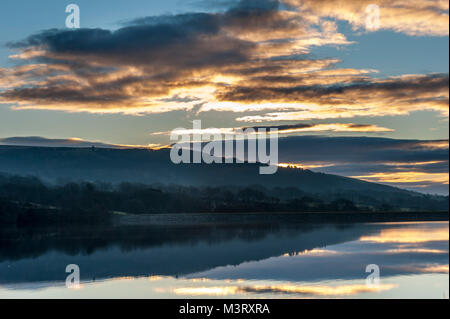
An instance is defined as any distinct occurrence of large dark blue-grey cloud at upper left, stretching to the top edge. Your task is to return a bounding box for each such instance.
[9,0,288,68]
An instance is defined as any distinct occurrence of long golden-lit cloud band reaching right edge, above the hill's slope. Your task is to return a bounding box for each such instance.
[214,74,449,122]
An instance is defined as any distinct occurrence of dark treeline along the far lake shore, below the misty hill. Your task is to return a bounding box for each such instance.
[0,175,448,226]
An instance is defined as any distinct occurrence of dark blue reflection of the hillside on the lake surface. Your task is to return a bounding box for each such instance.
[0,223,377,284]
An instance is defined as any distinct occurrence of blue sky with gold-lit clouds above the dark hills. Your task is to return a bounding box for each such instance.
[0,0,449,194]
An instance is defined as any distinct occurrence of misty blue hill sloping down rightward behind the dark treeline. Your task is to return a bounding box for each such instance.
[0,146,448,209]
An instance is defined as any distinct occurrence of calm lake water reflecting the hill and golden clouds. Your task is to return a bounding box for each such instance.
[0,222,449,299]
